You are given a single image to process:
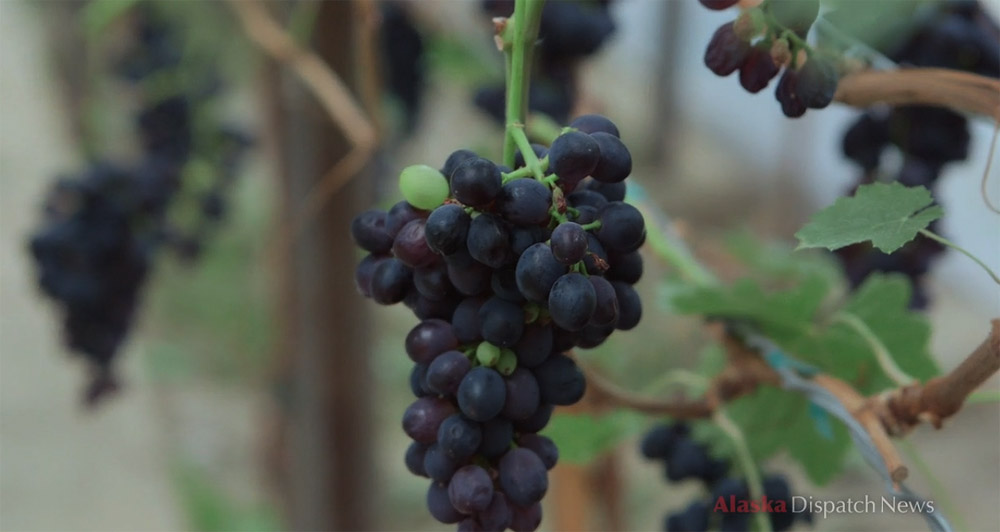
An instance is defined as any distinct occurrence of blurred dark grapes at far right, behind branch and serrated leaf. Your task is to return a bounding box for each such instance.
[828,1,1000,308]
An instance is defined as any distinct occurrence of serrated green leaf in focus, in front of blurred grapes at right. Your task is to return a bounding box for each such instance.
[795,182,944,253]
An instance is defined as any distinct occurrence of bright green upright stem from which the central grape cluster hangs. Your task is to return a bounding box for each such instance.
[501,0,545,166]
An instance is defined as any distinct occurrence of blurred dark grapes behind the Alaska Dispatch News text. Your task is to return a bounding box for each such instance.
[640,423,812,532]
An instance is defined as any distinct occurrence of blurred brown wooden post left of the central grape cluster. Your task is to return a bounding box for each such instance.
[272,1,375,530]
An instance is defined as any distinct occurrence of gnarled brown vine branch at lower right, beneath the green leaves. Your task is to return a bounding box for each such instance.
[584,319,1000,482]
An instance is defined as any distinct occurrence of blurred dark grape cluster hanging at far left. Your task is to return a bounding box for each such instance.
[29,4,249,404]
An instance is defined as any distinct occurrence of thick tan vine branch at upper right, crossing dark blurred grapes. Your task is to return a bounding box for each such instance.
[834,68,1000,122]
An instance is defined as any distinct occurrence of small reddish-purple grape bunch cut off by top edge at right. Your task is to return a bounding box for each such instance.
[700,0,840,118]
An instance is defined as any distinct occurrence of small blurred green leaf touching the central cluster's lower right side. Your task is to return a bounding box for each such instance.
[543,410,643,464]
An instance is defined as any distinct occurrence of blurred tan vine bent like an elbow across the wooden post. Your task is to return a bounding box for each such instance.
[228,0,378,235]
